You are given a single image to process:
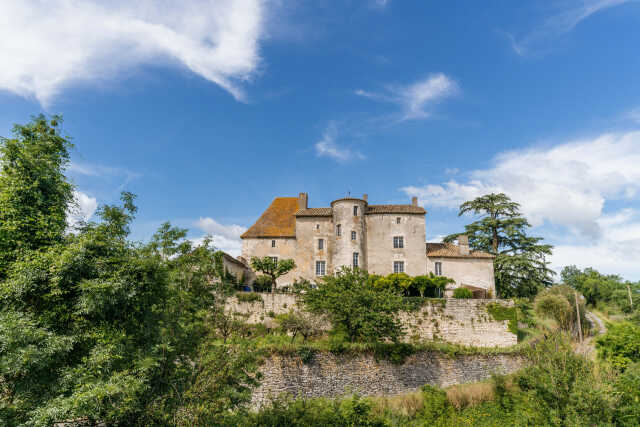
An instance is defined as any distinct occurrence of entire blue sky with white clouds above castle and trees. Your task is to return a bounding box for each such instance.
[0,0,640,280]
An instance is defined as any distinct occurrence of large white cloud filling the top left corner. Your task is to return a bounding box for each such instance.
[0,0,264,104]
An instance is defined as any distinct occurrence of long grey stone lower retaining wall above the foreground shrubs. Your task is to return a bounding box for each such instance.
[252,351,524,407]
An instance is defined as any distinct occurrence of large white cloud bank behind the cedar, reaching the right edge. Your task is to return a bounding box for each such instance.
[402,132,640,278]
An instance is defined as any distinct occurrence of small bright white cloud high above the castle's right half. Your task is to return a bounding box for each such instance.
[354,73,459,120]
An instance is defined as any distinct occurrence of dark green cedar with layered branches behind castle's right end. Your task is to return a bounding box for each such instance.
[444,193,555,298]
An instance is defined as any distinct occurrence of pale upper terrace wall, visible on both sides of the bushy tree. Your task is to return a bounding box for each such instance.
[226,294,518,347]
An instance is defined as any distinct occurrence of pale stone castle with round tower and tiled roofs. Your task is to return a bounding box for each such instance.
[241,193,495,297]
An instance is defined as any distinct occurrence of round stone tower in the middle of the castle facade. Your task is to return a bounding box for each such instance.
[331,198,367,270]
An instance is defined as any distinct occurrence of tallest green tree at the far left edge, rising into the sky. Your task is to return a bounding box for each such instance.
[0,115,73,280]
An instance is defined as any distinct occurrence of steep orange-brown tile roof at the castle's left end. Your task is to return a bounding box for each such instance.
[240,197,298,239]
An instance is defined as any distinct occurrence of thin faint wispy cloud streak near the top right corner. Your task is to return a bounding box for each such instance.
[505,0,635,56]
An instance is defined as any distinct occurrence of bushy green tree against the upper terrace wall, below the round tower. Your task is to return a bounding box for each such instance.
[300,267,404,342]
